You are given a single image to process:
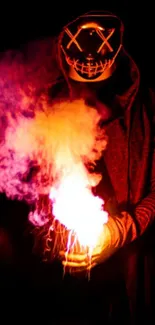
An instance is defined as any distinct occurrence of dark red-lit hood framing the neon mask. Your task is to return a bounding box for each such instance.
[53,11,140,114]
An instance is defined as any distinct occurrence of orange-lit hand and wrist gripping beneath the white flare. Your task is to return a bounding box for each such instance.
[60,212,137,273]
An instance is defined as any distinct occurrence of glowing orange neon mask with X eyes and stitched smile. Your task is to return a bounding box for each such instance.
[61,12,123,81]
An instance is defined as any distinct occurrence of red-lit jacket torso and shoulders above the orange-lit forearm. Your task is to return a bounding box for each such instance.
[51,42,155,238]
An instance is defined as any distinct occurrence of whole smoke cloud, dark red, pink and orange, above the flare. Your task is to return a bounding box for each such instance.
[0,40,107,228]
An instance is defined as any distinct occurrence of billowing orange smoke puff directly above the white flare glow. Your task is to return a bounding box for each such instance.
[6,100,107,175]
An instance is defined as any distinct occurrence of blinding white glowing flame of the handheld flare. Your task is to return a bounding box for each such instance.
[50,170,108,254]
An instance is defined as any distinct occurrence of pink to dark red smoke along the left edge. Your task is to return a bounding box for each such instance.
[0,39,59,201]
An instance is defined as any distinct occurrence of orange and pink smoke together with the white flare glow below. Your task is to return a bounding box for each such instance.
[1,93,107,251]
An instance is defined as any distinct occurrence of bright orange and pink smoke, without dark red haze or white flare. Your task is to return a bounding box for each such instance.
[0,99,106,201]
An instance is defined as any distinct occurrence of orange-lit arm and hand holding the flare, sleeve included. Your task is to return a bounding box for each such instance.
[59,90,155,270]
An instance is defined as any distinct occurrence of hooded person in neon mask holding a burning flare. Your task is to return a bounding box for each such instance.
[46,11,155,324]
